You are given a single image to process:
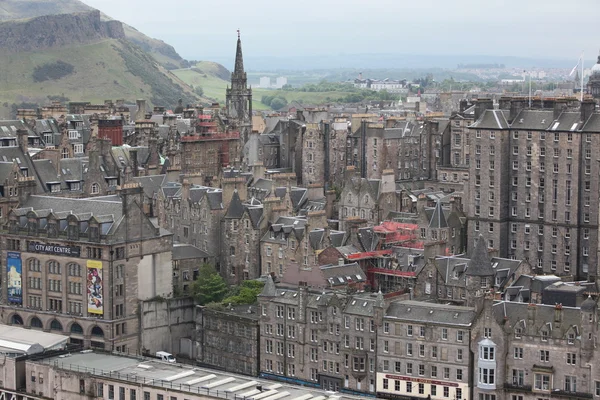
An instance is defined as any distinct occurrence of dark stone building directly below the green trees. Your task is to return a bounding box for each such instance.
[196,305,261,376]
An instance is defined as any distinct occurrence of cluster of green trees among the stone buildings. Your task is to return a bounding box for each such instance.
[191,264,264,306]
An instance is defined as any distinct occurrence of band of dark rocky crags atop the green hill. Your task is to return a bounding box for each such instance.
[0,10,125,54]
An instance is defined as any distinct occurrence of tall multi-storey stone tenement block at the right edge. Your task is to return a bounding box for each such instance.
[466,98,600,279]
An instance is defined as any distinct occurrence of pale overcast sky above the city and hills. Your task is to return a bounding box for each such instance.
[83,0,600,66]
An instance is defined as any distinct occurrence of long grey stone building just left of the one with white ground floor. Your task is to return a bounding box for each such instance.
[259,276,385,394]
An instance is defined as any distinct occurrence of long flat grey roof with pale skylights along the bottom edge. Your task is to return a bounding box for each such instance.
[43,350,362,400]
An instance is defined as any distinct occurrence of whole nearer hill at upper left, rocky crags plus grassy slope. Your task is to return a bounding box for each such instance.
[0,11,197,117]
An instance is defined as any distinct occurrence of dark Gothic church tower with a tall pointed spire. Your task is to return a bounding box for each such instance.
[225,30,252,164]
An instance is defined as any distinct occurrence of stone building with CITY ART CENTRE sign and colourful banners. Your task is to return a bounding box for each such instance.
[0,184,172,352]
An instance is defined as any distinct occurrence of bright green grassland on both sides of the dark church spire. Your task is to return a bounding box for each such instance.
[172,61,356,110]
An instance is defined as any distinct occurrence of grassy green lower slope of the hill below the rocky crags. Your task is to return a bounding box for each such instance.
[0,39,195,117]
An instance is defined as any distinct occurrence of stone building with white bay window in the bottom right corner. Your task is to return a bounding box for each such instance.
[471,298,600,400]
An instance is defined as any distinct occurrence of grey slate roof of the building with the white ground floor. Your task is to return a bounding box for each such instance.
[384,300,477,327]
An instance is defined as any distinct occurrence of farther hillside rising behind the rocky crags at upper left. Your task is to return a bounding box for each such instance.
[0,0,188,69]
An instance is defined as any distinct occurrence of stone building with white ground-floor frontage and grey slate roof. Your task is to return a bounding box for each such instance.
[377,300,477,400]
